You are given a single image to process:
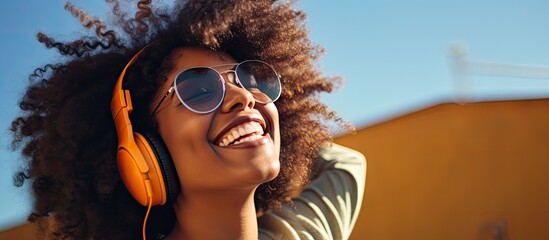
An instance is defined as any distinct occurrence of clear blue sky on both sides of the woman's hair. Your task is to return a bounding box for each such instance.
[0,0,549,230]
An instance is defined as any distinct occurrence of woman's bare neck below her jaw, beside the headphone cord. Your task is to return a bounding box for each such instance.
[167,189,258,240]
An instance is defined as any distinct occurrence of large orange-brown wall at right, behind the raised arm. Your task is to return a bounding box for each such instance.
[336,99,549,240]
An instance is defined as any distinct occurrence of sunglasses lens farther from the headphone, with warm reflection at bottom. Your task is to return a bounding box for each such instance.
[235,60,281,103]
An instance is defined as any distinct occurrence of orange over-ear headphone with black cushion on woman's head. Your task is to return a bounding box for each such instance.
[111,41,179,206]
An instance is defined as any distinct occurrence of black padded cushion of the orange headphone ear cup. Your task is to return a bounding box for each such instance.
[135,131,179,204]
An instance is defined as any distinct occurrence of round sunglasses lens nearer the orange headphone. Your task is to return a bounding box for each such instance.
[175,68,225,113]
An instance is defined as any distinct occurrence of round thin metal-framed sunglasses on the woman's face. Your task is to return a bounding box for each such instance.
[152,60,282,115]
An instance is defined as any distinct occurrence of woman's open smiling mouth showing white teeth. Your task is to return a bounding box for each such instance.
[216,121,266,147]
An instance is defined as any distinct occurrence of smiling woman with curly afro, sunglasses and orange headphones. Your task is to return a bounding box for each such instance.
[8,0,365,239]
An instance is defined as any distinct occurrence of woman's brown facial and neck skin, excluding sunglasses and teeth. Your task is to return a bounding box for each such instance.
[151,47,280,240]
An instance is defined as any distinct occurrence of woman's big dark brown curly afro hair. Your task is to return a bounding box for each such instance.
[11,0,346,239]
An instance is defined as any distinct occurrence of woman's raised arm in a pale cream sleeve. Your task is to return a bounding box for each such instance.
[259,144,366,240]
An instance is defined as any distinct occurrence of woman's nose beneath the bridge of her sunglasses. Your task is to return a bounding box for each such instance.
[221,81,255,113]
